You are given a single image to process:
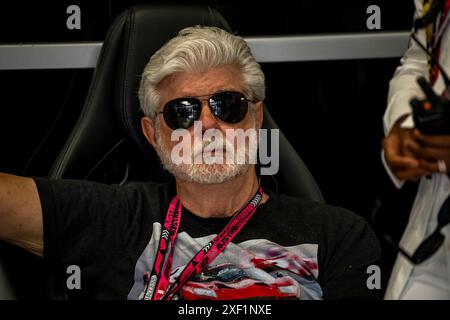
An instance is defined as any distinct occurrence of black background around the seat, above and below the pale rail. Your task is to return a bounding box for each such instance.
[0,0,414,292]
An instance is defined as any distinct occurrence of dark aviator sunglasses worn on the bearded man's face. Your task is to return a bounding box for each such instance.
[159,91,254,130]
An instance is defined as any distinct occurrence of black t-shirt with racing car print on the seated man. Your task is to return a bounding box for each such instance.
[35,178,381,300]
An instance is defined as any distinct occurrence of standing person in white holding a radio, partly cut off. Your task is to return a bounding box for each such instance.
[382,0,450,299]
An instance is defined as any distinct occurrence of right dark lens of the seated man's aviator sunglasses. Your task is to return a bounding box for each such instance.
[209,91,248,123]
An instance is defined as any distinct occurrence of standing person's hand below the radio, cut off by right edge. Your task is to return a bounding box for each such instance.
[406,129,450,173]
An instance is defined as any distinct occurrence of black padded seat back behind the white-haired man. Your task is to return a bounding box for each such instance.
[49,5,323,201]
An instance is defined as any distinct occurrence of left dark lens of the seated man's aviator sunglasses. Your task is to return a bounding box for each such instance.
[163,98,201,130]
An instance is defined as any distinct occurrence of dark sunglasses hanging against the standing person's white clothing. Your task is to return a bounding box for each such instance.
[386,196,450,264]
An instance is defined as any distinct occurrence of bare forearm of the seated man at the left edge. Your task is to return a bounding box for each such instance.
[0,173,44,256]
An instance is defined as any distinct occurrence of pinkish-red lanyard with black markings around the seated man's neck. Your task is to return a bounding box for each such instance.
[143,186,263,300]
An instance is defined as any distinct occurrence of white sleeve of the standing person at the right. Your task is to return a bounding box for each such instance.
[383,1,427,135]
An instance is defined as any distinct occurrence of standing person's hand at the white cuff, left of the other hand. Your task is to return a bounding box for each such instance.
[382,119,430,180]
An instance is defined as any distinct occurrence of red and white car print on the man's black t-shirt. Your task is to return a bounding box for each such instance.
[128,223,322,300]
